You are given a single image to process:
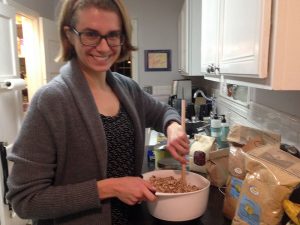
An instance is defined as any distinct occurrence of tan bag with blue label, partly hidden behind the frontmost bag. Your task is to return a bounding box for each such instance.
[223,125,281,220]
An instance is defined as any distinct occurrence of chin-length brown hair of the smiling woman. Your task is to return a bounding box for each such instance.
[56,0,137,62]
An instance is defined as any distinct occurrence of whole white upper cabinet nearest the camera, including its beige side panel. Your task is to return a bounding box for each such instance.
[201,0,300,90]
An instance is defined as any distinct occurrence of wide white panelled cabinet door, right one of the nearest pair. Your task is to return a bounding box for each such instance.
[219,0,271,78]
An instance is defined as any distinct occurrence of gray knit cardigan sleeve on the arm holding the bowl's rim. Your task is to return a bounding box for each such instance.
[7,85,101,219]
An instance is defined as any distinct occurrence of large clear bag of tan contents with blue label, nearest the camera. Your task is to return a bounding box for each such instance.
[232,145,300,225]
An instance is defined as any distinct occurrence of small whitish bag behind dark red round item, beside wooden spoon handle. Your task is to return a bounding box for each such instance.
[189,134,216,173]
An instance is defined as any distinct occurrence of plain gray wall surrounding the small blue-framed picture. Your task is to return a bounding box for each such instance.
[125,0,183,87]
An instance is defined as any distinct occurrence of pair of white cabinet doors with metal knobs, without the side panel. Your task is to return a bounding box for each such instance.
[202,0,271,78]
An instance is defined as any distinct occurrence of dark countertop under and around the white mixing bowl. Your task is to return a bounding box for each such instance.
[131,157,231,225]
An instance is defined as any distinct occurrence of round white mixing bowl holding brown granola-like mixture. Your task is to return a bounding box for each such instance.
[143,170,210,222]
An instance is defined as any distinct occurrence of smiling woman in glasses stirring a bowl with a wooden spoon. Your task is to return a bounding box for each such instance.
[7,0,188,225]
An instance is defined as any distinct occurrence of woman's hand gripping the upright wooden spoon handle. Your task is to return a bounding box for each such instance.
[167,121,189,164]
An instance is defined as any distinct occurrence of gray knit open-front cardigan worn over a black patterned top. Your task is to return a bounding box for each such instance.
[7,59,180,225]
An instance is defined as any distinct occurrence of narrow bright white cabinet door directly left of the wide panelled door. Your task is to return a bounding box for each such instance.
[201,0,220,73]
